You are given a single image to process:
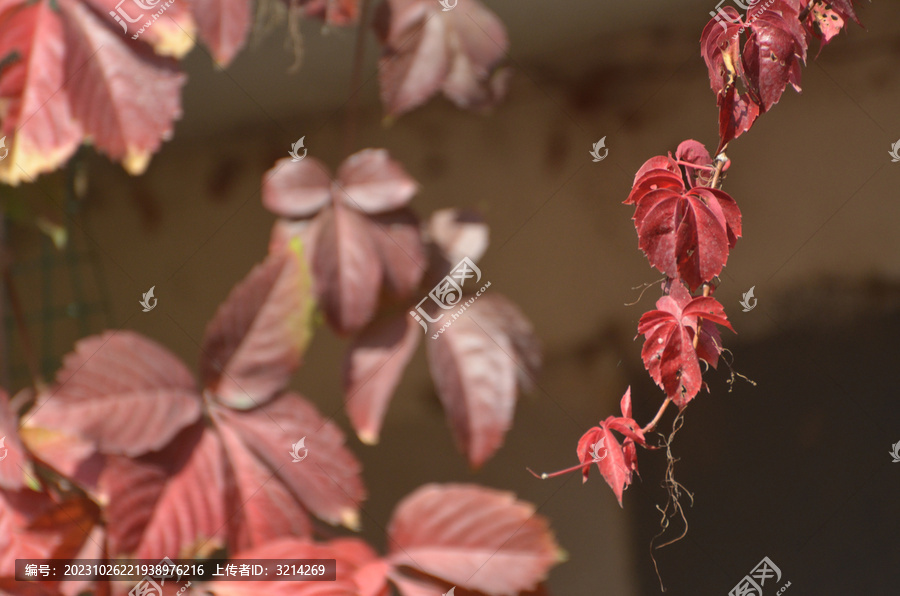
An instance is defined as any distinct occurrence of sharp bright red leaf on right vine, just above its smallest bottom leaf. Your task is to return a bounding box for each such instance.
[638,281,734,408]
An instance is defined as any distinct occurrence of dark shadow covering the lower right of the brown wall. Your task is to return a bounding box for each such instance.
[625,282,900,596]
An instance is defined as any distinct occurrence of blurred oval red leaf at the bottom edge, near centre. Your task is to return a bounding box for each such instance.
[388,484,559,596]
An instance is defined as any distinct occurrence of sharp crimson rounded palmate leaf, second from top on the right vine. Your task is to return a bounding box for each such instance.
[625,151,741,289]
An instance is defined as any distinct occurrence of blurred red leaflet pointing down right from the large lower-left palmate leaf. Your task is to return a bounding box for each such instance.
[210,393,365,527]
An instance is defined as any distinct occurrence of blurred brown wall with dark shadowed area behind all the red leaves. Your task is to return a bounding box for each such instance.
[0,0,900,596]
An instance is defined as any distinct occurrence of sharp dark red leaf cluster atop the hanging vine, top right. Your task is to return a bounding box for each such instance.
[700,0,859,153]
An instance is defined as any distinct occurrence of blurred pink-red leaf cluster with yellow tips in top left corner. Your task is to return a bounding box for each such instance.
[0,0,356,184]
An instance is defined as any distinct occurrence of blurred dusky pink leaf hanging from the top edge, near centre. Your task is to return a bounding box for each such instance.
[376,0,509,116]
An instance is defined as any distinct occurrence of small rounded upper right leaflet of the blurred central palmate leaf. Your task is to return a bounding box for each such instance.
[336,149,418,214]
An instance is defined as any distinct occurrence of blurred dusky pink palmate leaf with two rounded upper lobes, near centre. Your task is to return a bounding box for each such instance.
[263,149,425,334]
